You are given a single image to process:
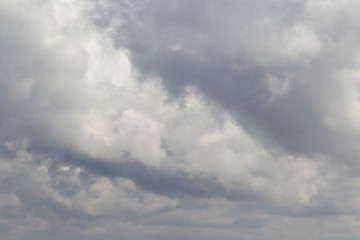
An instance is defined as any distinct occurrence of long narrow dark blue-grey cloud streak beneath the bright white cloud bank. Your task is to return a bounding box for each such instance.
[62,152,259,200]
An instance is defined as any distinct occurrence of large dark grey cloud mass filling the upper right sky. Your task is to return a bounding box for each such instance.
[115,1,359,164]
